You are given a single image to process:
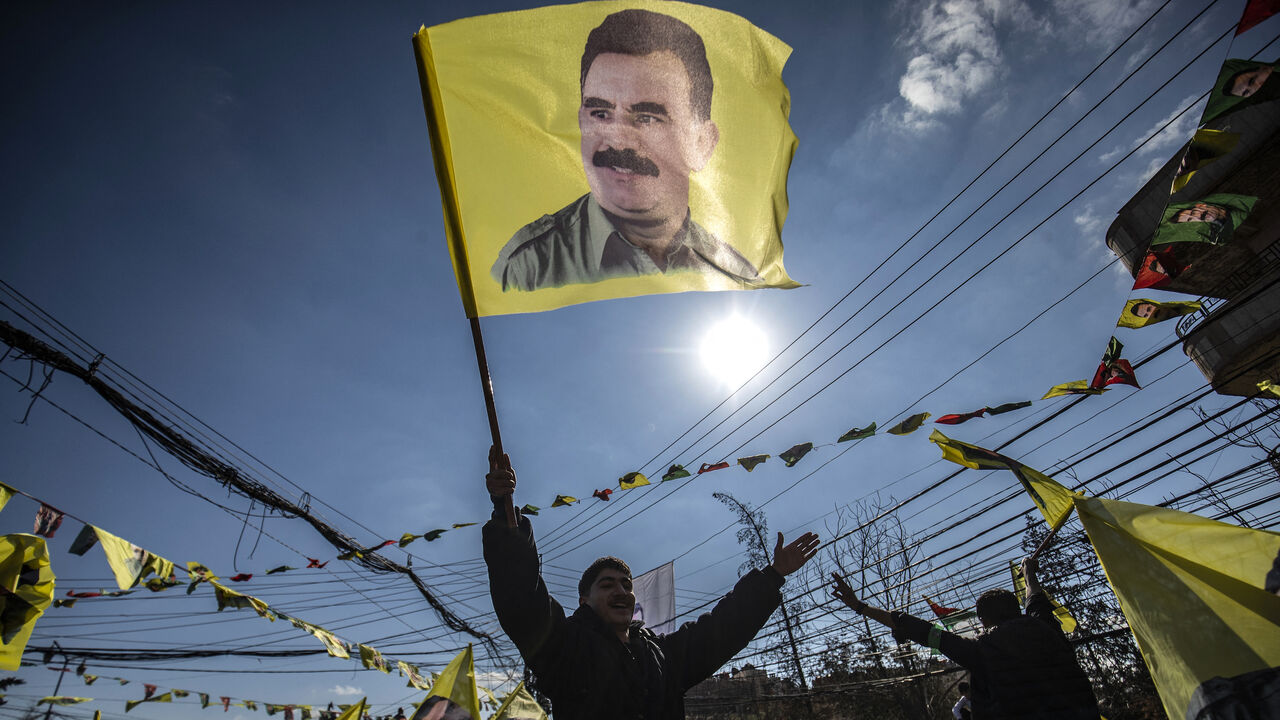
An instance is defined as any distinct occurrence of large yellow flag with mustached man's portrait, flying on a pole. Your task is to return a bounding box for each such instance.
[413,0,799,318]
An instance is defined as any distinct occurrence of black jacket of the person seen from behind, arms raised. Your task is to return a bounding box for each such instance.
[893,592,1098,720]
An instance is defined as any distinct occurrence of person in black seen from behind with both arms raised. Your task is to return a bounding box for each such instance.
[832,557,1100,720]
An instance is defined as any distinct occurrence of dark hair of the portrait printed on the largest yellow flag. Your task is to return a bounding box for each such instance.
[579,9,714,120]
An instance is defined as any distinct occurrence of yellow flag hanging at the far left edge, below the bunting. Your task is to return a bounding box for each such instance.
[0,533,54,670]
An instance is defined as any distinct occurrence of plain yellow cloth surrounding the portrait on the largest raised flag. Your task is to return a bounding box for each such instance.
[413,0,799,318]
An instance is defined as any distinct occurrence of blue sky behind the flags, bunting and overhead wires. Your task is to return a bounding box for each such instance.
[0,0,1276,719]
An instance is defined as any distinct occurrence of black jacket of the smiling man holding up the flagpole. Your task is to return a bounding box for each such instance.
[484,511,782,720]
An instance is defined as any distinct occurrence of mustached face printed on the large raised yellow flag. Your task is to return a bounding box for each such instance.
[577,50,719,224]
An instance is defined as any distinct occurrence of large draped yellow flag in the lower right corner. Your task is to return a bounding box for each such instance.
[1076,497,1280,717]
